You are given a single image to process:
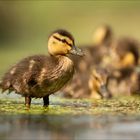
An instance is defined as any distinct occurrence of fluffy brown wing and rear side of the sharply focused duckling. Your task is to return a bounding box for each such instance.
[1,55,54,93]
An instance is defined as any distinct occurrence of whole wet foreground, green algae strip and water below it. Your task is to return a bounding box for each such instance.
[0,95,140,140]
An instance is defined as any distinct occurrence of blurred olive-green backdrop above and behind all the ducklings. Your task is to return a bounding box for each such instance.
[0,0,140,77]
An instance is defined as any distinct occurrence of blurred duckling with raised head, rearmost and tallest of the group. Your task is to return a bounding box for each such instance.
[72,24,113,72]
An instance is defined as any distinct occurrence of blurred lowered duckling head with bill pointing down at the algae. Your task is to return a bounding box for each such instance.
[89,68,111,98]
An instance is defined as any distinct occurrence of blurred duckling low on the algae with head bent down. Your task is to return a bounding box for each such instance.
[63,68,111,99]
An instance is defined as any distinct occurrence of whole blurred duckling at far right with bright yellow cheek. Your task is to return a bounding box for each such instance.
[108,38,139,95]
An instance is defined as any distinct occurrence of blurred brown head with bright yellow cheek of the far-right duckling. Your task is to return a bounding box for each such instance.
[111,37,139,68]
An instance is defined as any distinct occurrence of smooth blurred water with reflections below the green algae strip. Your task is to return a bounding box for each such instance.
[0,115,140,140]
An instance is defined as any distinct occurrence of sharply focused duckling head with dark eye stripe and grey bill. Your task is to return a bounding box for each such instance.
[48,29,83,56]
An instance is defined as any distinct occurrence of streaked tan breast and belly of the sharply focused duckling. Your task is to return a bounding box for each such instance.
[32,56,74,97]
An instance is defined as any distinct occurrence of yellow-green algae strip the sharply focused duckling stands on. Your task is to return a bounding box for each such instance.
[0,96,140,115]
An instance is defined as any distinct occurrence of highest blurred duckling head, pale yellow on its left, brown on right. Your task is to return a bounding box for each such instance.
[93,24,113,46]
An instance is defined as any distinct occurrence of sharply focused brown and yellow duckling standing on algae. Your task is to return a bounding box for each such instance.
[0,29,83,108]
